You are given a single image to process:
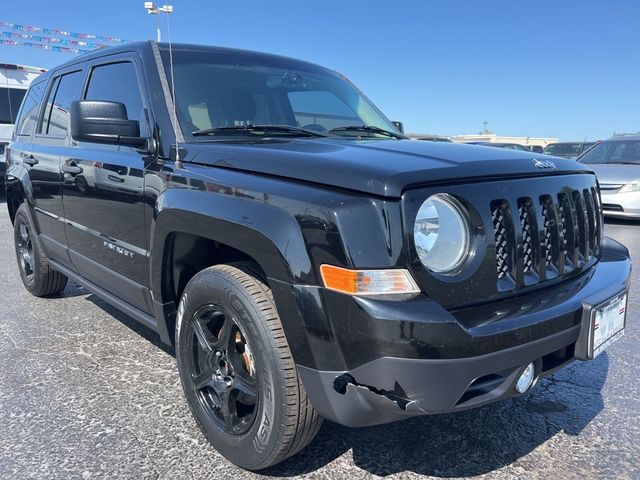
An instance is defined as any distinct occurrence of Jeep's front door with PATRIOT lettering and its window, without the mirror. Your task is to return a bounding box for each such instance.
[61,54,151,313]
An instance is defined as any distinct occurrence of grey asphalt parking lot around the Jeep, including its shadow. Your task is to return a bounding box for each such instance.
[0,198,640,479]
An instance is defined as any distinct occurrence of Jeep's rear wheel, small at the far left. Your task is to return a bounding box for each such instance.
[13,203,67,297]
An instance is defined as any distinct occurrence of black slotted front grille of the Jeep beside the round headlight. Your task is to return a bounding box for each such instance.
[491,188,602,291]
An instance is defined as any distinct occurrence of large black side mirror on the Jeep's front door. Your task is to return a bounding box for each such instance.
[71,100,147,147]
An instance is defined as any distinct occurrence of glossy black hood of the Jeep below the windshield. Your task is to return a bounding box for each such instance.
[184,138,592,197]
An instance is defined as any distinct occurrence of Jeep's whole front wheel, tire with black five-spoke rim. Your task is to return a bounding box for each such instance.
[176,264,322,470]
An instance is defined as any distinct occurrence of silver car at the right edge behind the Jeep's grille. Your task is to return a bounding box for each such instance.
[578,136,640,218]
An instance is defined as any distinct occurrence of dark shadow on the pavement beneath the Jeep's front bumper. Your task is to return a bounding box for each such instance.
[261,353,609,478]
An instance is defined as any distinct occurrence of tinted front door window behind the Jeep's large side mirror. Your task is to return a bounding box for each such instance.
[84,62,142,121]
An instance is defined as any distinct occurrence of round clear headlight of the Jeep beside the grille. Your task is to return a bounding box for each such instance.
[413,193,471,273]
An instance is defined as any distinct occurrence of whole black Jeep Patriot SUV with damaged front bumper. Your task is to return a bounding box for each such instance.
[6,42,631,469]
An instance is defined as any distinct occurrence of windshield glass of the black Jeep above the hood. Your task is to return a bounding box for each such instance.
[163,49,399,141]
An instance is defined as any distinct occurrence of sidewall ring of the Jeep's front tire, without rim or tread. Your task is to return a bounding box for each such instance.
[176,269,284,469]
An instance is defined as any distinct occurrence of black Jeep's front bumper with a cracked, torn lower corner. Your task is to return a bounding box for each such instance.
[298,238,631,427]
